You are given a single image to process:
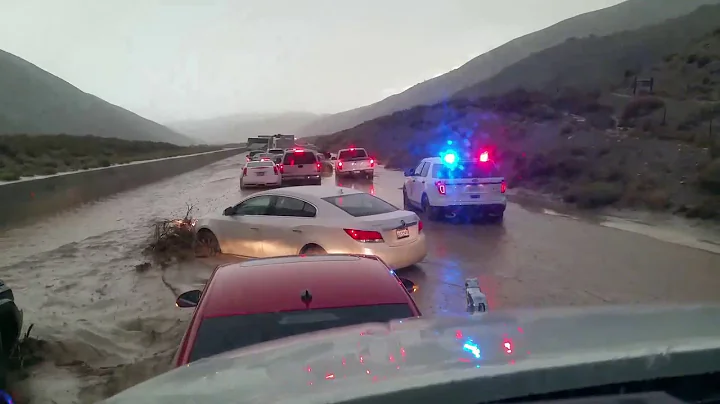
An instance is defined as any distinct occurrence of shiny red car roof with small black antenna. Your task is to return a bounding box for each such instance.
[201,255,410,317]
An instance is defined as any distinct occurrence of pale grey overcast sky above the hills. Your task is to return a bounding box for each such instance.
[0,0,624,122]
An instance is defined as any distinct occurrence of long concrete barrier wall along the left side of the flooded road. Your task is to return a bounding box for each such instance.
[0,148,246,227]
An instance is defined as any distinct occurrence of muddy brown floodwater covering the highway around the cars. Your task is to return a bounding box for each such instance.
[0,153,720,403]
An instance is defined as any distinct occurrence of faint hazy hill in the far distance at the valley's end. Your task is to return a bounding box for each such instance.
[167,112,320,144]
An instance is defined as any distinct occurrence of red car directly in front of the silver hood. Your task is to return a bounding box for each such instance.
[175,254,420,366]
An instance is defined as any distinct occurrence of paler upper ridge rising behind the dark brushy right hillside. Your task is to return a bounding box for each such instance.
[298,0,720,136]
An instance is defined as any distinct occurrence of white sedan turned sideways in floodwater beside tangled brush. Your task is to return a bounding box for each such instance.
[195,186,427,268]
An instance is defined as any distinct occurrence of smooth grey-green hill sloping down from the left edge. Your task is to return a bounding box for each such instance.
[0,50,197,145]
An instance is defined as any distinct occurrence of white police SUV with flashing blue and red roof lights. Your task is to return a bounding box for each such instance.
[403,151,507,221]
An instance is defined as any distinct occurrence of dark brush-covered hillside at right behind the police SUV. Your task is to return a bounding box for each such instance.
[309,20,720,219]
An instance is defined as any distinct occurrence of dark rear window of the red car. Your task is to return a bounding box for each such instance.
[190,304,415,362]
